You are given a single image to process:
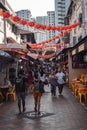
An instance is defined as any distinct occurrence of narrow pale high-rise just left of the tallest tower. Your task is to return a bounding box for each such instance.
[47,11,55,43]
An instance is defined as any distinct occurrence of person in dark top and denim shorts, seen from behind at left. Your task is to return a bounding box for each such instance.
[15,73,27,114]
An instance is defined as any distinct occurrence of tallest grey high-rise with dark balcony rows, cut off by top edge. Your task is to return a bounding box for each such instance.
[55,0,70,35]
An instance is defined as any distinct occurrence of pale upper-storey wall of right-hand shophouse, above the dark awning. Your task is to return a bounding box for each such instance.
[69,0,83,46]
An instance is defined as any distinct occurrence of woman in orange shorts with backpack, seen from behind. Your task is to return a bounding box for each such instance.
[33,75,43,115]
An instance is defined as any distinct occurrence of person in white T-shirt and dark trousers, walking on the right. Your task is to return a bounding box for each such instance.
[56,69,65,95]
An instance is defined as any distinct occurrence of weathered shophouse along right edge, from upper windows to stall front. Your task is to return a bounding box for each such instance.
[64,0,87,81]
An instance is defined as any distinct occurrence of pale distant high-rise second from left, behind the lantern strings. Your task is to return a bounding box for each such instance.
[35,16,48,43]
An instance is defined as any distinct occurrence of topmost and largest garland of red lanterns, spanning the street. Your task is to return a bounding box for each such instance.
[0,9,80,31]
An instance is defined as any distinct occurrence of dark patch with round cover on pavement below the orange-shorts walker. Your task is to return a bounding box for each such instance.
[19,111,54,119]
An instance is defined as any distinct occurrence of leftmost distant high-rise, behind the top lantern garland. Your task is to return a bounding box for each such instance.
[16,9,32,31]
